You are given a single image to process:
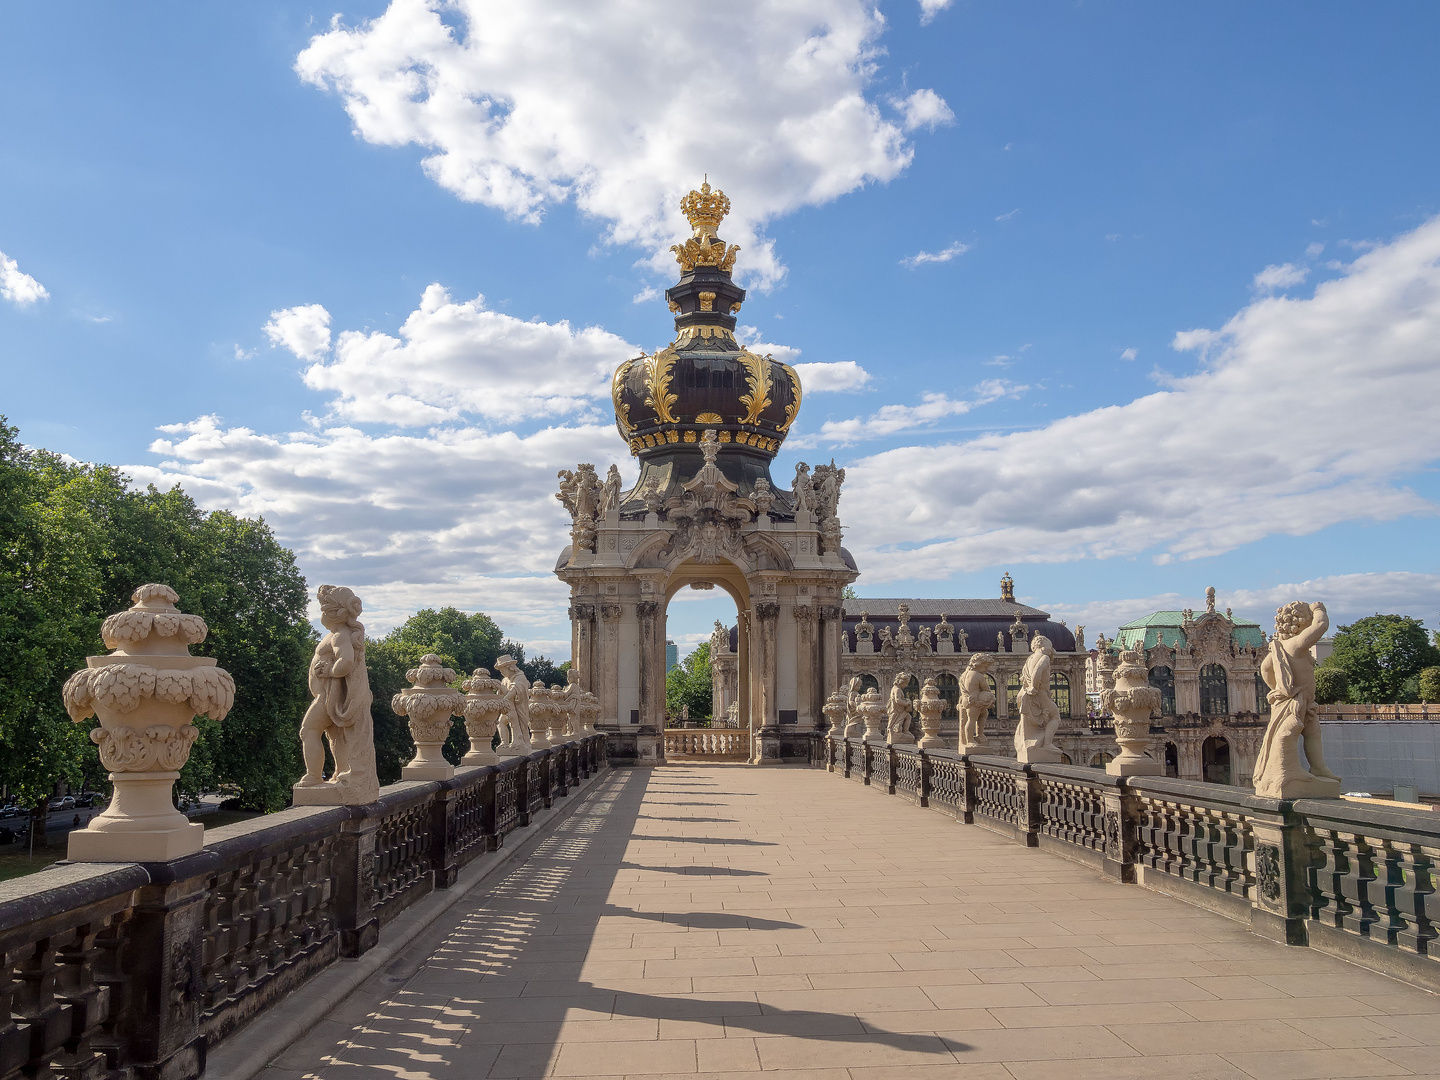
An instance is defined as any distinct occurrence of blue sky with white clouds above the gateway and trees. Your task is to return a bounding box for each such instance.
[0,0,1440,655]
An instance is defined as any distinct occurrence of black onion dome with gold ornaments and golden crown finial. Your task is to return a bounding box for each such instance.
[611,183,801,494]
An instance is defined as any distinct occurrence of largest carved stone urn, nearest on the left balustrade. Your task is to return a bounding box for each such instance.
[63,585,235,863]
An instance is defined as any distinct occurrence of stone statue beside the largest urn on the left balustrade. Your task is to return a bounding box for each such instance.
[294,585,380,806]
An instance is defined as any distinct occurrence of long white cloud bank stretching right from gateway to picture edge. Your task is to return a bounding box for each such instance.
[845,219,1440,579]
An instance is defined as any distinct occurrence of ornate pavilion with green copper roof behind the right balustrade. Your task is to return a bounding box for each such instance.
[1086,588,1270,786]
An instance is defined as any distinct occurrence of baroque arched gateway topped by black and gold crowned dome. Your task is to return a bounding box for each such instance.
[554,184,858,763]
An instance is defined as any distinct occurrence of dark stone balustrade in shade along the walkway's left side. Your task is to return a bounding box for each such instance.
[0,734,606,1080]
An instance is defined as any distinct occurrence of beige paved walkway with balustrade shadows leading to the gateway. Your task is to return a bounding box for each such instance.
[262,766,1440,1080]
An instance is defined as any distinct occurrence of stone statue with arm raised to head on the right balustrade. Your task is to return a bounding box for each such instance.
[1256,600,1341,799]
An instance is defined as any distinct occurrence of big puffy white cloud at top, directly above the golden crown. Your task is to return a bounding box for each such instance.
[295,0,949,287]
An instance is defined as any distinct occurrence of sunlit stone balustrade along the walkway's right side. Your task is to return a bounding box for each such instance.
[811,736,1440,991]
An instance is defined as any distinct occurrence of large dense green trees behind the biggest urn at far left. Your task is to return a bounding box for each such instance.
[0,419,314,809]
